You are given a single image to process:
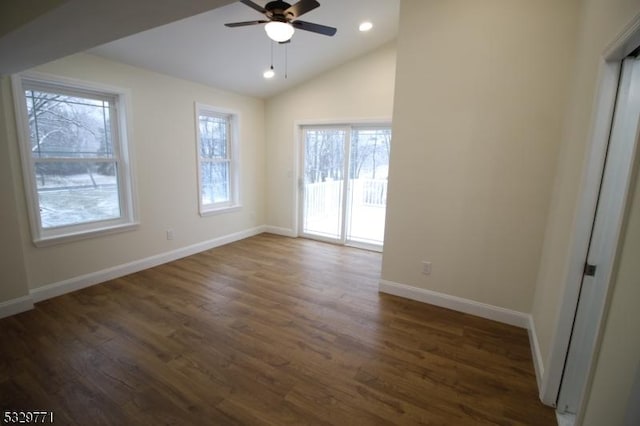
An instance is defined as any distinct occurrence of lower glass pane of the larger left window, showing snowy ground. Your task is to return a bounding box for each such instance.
[35,161,121,229]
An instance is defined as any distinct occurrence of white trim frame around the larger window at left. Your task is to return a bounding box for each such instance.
[11,72,139,247]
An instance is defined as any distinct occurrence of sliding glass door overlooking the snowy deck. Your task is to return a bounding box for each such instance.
[300,126,391,248]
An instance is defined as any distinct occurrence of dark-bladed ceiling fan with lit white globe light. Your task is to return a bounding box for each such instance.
[225,0,337,43]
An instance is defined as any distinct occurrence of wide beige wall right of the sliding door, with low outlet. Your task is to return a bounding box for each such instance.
[382,0,577,313]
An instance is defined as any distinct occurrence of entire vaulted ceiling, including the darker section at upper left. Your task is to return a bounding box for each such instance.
[0,0,400,97]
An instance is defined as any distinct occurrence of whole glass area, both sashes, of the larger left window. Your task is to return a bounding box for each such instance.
[25,89,121,229]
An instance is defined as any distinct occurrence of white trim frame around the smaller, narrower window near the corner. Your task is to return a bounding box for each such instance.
[195,102,242,216]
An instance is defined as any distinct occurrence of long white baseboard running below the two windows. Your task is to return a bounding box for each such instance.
[30,226,265,303]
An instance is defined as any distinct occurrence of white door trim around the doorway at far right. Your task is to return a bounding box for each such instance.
[540,10,640,416]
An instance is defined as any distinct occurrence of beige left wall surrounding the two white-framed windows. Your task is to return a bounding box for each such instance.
[2,54,266,291]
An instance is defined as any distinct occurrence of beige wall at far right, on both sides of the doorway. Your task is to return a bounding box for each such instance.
[532,0,640,420]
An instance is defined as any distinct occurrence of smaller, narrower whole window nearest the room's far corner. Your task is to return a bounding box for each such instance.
[196,104,240,214]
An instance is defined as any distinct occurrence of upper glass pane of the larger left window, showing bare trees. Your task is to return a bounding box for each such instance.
[25,90,113,158]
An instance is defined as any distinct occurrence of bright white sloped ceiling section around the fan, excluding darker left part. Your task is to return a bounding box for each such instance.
[89,0,400,98]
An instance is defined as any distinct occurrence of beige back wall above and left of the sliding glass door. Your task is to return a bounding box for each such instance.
[266,43,396,232]
